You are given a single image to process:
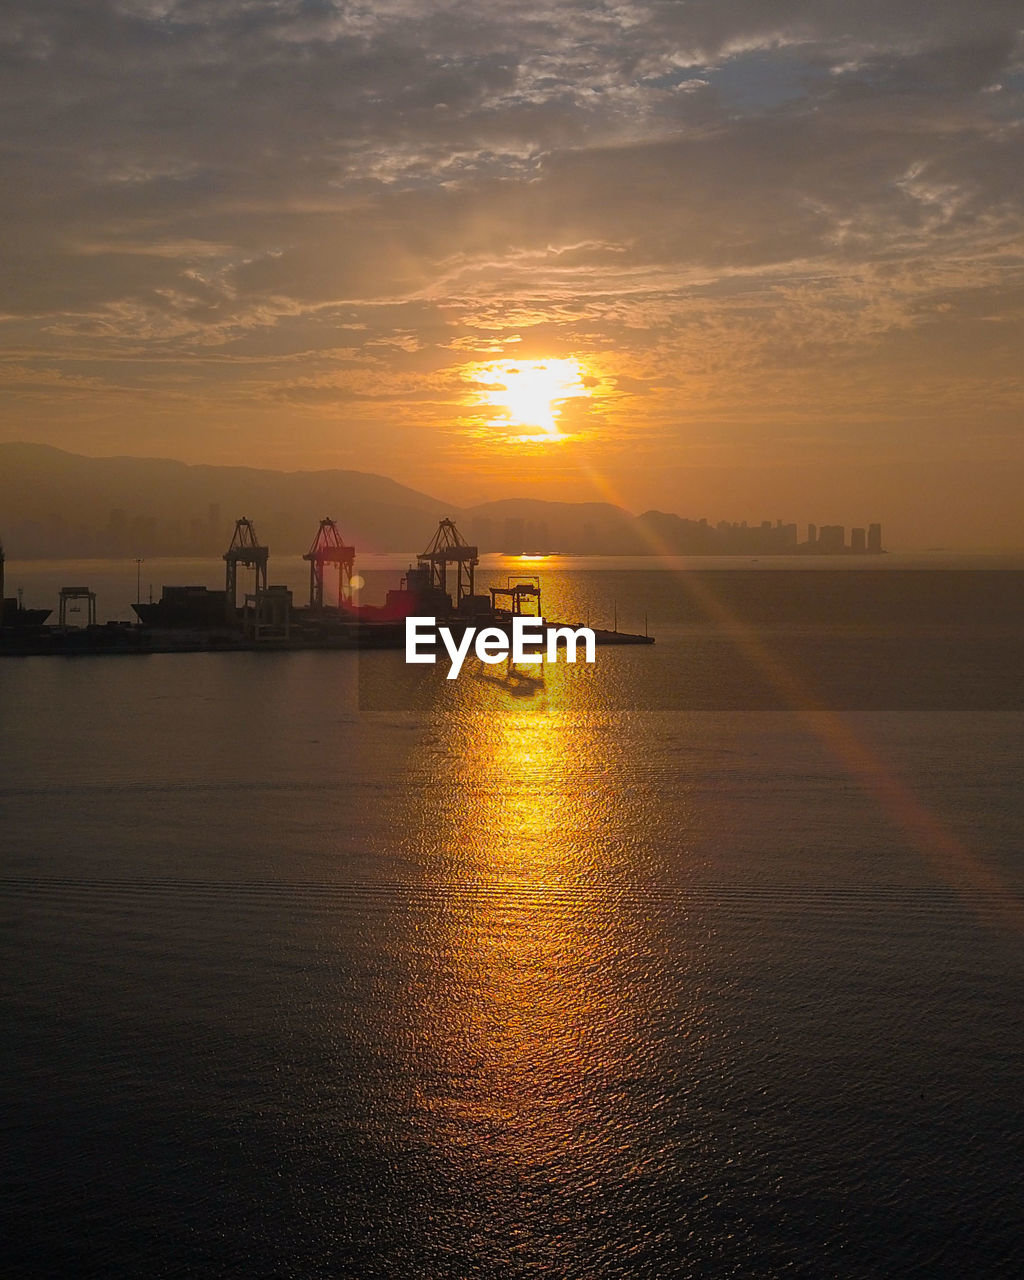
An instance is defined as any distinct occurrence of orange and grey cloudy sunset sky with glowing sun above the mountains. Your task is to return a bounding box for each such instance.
[0,0,1024,547]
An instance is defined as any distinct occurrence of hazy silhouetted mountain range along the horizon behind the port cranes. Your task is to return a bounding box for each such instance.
[0,444,881,559]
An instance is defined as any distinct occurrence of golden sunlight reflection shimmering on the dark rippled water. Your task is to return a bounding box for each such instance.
[386,663,703,1274]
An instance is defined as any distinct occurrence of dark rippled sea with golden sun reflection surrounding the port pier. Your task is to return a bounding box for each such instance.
[0,556,1024,1280]
